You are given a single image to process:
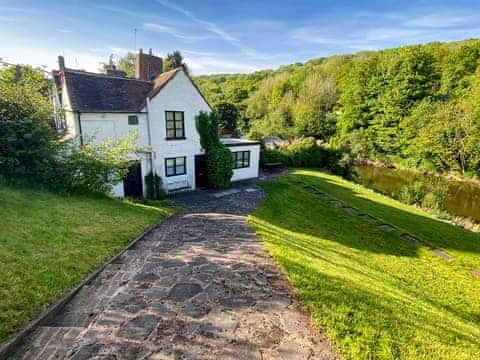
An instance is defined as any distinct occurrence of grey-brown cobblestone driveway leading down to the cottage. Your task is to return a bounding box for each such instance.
[20,185,334,359]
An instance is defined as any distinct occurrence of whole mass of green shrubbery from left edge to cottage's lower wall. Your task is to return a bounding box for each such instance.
[0,66,140,193]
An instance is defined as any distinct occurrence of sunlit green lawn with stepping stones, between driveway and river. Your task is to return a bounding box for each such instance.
[250,170,480,359]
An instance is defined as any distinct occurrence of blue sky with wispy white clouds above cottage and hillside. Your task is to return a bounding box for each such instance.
[0,0,480,75]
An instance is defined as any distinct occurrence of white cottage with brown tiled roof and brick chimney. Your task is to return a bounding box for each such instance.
[55,50,260,197]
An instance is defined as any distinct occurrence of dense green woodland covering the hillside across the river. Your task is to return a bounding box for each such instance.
[195,40,480,176]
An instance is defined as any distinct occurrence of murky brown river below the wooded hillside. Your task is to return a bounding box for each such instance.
[355,165,480,222]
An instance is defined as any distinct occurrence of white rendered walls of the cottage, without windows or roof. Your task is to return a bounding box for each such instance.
[66,71,260,197]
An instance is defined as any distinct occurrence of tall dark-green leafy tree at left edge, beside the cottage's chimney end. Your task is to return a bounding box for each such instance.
[0,67,61,178]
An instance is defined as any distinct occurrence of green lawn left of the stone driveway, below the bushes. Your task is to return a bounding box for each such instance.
[0,185,173,343]
